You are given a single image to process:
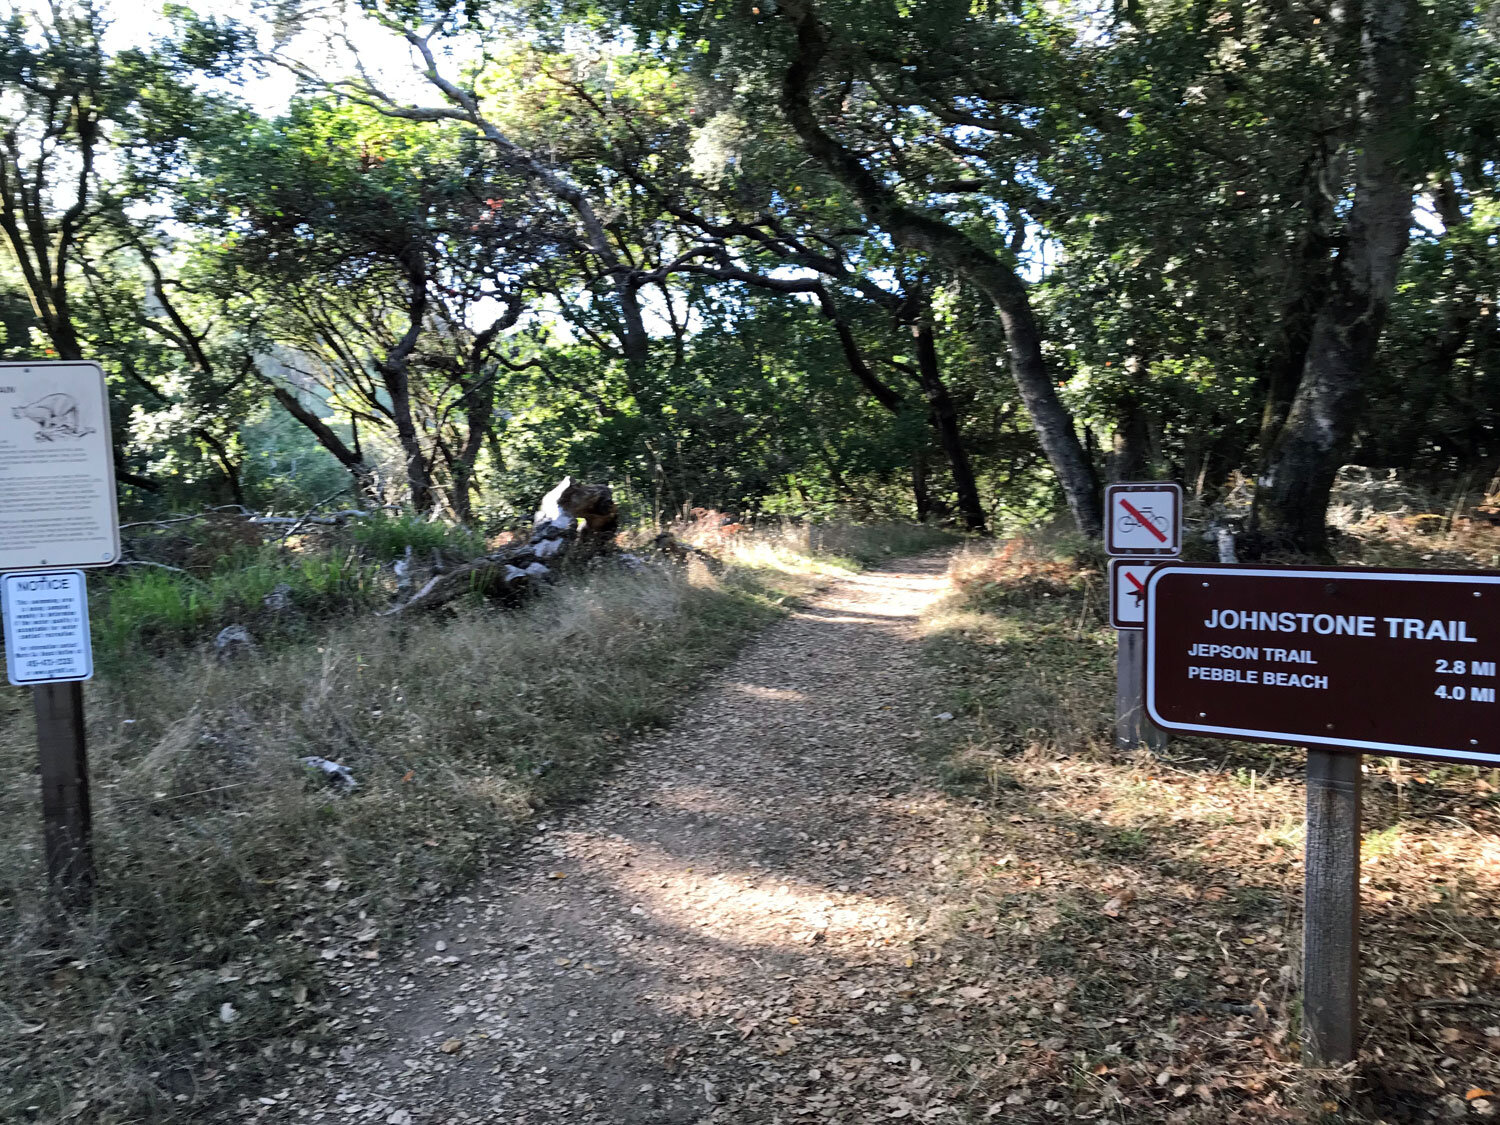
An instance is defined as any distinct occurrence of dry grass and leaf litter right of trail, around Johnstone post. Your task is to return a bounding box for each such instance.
[929,546,1500,1125]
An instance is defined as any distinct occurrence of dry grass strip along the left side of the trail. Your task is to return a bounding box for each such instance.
[0,537,876,1125]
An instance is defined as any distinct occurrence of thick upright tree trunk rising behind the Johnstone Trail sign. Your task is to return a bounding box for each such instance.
[1257,0,1416,555]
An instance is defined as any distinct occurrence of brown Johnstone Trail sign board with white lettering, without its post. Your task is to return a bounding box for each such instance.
[1146,563,1500,765]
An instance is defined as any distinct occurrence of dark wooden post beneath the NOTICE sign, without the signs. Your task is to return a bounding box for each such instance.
[32,683,93,911]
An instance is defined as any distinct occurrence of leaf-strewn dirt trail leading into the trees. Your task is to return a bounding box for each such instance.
[261,555,984,1125]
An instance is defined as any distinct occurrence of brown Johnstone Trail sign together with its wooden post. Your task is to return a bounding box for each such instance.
[1145,563,1500,1064]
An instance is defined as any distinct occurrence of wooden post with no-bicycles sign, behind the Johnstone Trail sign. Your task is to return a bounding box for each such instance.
[1104,482,1182,752]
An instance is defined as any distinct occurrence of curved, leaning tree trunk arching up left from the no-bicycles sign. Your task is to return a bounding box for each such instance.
[779,0,1104,537]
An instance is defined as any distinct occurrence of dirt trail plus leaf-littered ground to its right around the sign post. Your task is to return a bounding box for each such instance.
[225,555,1500,1125]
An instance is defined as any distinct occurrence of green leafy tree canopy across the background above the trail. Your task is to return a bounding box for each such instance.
[0,0,1500,533]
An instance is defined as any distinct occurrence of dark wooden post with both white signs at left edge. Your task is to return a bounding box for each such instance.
[0,362,120,911]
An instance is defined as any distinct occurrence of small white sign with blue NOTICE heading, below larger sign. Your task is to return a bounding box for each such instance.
[0,570,93,686]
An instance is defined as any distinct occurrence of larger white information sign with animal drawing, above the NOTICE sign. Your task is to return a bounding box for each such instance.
[0,362,120,570]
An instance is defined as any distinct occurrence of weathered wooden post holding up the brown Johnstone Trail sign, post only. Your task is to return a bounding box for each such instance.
[1302,749,1362,1067]
